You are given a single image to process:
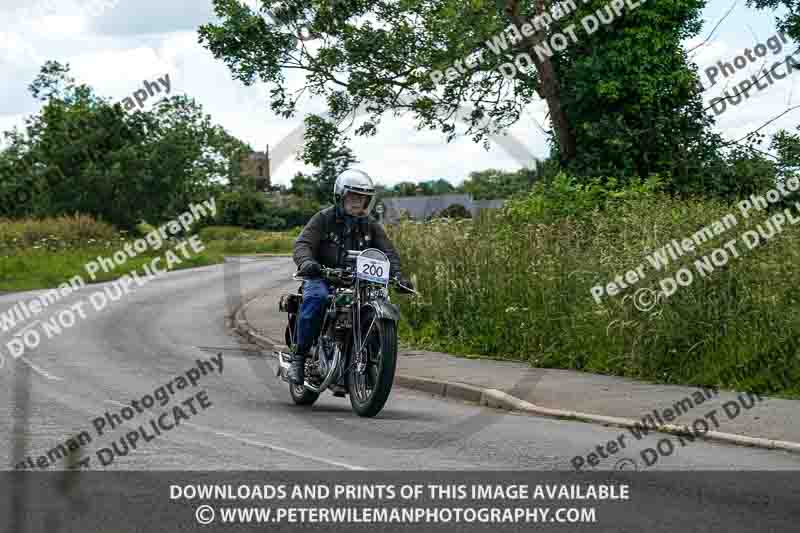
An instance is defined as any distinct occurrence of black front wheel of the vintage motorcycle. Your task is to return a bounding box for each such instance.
[347,313,397,417]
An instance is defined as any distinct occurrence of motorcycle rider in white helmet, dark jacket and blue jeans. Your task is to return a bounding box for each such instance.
[288,169,413,385]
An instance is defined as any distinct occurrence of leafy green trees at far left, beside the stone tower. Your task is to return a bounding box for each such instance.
[0,61,246,228]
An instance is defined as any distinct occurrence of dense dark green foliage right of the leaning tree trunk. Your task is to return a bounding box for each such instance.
[554,0,712,181]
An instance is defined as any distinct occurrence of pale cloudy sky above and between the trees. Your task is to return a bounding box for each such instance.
[0,0,800,185]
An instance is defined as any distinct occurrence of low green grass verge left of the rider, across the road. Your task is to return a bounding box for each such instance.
[0,217,297,292]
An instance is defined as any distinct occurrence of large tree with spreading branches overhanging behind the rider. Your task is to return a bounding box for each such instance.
[199,0,707,181]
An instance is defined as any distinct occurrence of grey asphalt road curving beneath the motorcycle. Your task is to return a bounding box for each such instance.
[0,258,800,531]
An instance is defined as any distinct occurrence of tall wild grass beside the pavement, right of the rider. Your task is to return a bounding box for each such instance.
[389,194,800,397]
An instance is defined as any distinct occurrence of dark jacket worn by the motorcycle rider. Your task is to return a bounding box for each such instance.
[292,207,401,276]
